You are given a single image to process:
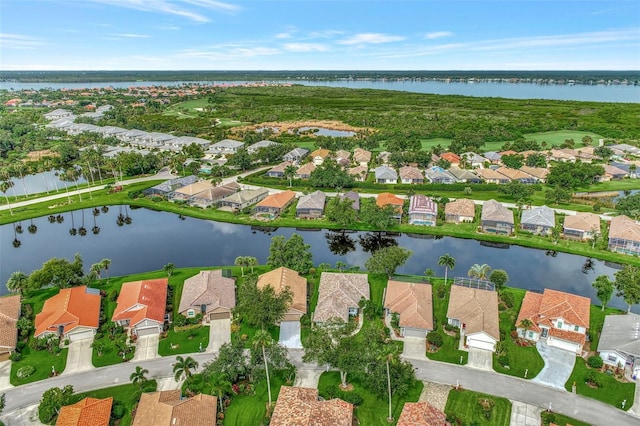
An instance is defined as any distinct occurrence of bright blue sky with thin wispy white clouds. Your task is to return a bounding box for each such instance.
[0,0,640,70]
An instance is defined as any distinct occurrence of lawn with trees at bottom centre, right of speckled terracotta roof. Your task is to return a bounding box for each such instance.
[318,371,424,425]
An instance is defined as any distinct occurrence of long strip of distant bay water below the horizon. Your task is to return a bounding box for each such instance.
[0,80,640,103]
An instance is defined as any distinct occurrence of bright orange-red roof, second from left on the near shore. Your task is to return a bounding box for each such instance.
[112,278,169,327]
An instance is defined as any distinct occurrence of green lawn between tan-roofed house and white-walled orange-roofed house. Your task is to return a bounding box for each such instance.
[493,288,544,379]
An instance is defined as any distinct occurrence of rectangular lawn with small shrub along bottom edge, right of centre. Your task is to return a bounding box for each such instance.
[444,389,511,426]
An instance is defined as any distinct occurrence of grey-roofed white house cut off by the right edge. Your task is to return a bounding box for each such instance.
[598,312,640,379]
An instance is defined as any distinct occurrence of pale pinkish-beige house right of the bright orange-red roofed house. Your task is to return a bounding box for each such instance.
[178,269,236,322]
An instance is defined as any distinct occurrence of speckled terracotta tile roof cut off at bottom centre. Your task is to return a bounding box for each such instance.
[269,386,353,426]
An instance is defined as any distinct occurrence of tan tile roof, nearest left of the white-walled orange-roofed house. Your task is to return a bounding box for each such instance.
[447,285,500,341]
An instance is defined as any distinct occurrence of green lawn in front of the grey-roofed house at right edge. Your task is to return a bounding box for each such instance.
[564,357,636,411]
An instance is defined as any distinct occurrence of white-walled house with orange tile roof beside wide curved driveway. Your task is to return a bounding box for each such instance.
[516,288,591,355]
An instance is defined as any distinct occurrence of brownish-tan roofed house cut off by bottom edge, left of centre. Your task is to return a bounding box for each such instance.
[132,389,218,426]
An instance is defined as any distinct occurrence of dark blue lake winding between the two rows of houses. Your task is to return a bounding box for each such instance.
[0,206,638,308]
